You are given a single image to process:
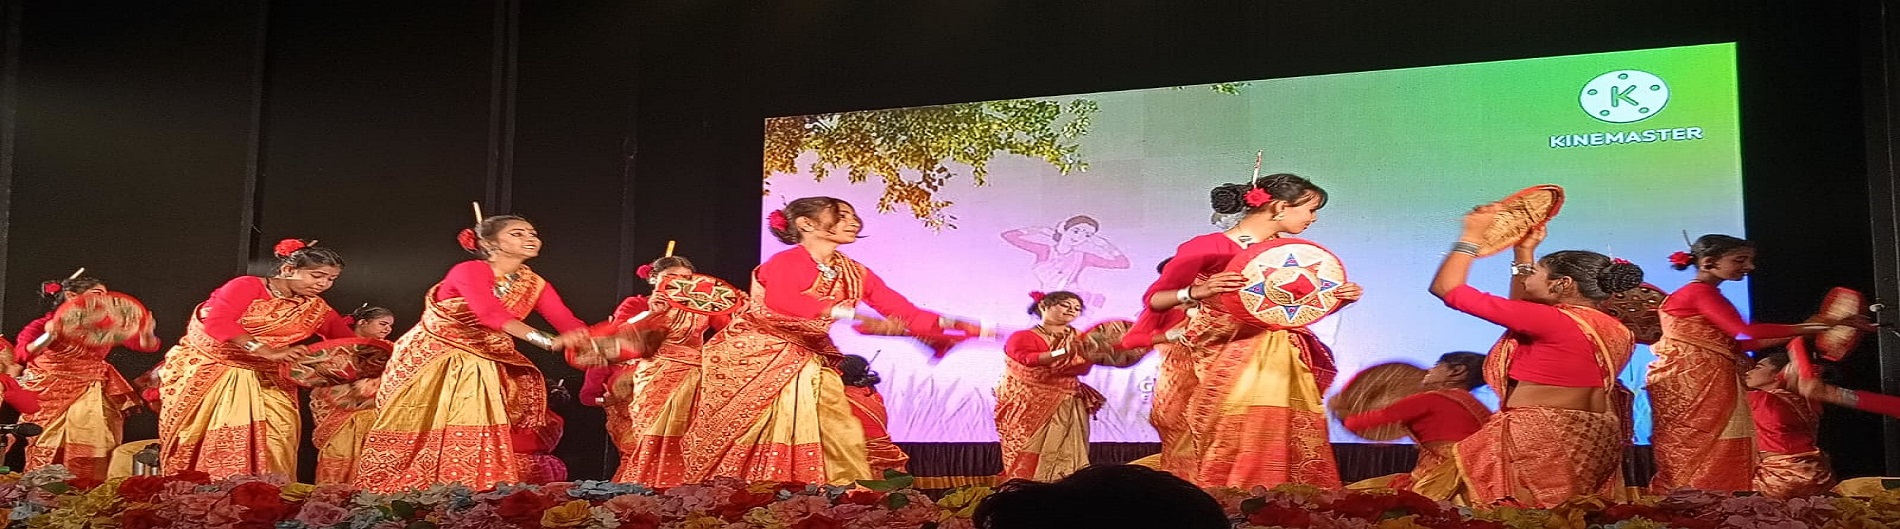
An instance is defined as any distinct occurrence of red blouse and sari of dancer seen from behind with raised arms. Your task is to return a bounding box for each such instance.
[1444,285,1636,508]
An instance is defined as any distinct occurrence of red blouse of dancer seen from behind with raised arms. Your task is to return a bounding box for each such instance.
[1444,285,1609,388]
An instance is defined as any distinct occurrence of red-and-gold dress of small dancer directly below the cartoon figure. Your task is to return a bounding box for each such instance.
[996,327,1108,481]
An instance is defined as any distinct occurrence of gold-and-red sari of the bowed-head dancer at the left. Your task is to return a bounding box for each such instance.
[158,289,333,480]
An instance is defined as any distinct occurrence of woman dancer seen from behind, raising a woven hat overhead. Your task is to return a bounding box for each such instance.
[1431,204,1644,508]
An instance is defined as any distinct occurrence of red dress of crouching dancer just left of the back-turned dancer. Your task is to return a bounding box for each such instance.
[1345,390,1492,500]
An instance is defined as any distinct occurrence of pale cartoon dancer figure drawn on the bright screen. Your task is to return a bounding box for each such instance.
[1003,215,1129,304]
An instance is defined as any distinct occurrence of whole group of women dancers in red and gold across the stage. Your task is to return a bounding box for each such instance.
[3,173,1900,506]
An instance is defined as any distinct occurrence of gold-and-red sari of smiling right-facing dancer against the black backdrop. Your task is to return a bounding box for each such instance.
[355,266,547,493]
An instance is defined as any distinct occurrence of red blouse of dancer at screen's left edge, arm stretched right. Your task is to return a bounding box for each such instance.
[752,245,942,335]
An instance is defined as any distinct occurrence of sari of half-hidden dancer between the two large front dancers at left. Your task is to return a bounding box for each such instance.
[310,379,382,485]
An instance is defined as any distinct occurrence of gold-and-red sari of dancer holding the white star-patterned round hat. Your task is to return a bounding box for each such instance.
[1169,304,1341,489]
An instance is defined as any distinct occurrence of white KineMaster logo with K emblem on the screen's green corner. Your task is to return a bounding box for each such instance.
[1550,70,1702,148]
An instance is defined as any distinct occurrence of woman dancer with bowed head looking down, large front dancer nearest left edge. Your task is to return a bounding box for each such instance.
[158,240,352,480]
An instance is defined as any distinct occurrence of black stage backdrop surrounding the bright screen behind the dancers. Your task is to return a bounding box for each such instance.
[0,0,1900,478]
